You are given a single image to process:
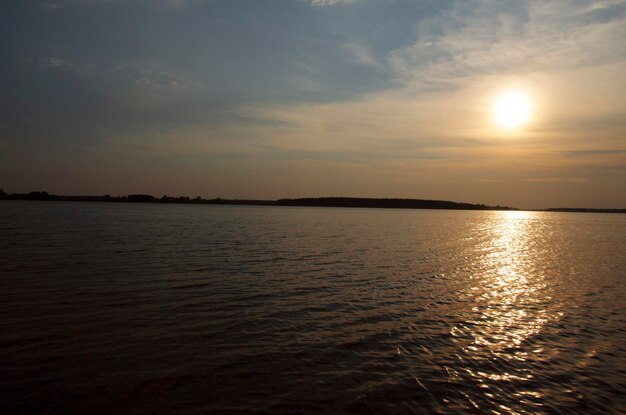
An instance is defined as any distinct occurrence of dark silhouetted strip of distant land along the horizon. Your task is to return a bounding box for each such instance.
[0,189,626,213]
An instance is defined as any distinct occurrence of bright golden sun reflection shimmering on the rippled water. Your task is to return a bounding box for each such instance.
[450,211,560,406]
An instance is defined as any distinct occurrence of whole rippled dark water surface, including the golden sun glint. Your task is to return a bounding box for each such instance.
[0,202,626,414]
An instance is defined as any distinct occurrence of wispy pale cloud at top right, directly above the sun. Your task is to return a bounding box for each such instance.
[389,1,626,86]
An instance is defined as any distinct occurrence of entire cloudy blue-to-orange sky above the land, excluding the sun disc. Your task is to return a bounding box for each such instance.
[0,0,626,208]
